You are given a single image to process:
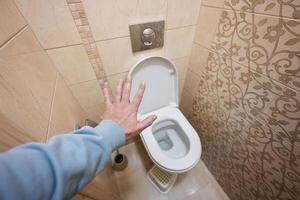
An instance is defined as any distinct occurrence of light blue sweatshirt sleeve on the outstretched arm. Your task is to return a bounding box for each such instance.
[0,120,125,200]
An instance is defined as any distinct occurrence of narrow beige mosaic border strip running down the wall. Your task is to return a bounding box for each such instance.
[66,0,107,87]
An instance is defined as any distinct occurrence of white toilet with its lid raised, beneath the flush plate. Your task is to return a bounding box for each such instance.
[129,56,201,174]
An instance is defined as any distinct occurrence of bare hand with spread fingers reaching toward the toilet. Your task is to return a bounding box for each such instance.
[102,77,156,140]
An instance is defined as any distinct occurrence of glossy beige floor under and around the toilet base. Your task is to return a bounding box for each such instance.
[115,140,229,200]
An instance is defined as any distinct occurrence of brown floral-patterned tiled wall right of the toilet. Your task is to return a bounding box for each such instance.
[186,0,300,200]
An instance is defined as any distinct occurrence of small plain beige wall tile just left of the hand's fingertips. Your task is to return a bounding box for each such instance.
[70,80,103,109]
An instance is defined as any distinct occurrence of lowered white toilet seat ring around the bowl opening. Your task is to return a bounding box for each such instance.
[140,106,201,173]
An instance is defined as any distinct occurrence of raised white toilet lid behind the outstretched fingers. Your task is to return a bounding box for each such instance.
[129,56,178,115]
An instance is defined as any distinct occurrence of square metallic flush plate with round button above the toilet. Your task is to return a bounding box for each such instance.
[129,21,165,52]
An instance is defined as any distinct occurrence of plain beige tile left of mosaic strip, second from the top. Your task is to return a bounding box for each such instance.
[47,45,96,85]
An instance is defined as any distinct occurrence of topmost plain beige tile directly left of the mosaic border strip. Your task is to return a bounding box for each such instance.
[15,0,81,48]
